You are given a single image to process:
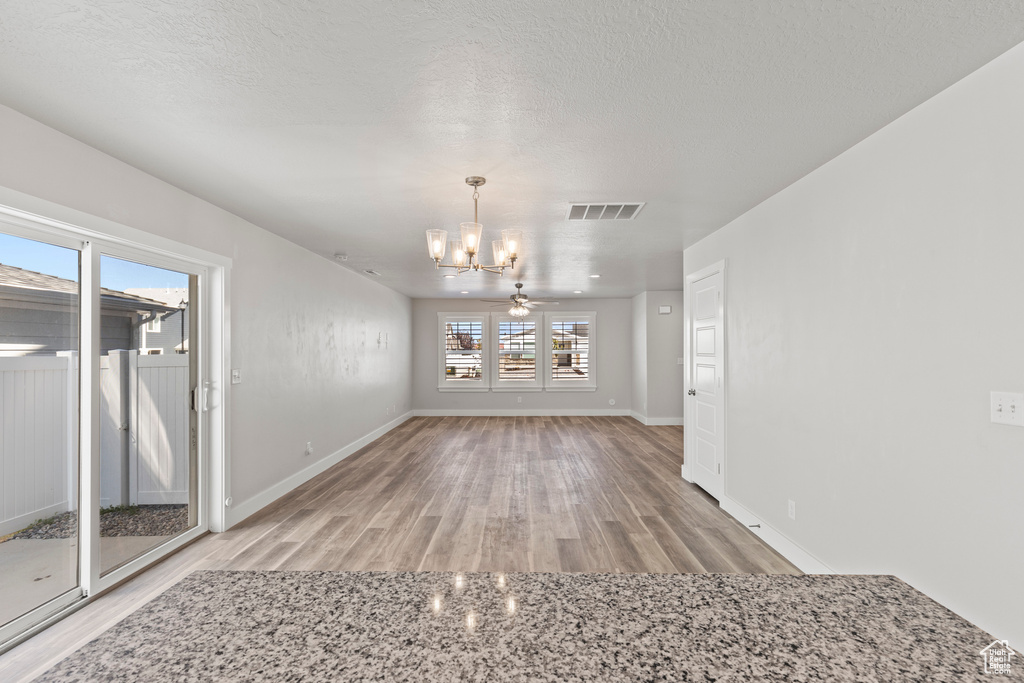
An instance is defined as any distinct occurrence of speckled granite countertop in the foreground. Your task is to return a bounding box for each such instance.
[34,571,1024,682]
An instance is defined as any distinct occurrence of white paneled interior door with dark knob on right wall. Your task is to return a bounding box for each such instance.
[685,269,725,500]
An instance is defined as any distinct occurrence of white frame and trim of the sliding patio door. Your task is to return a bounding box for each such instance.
[0,198,231,652]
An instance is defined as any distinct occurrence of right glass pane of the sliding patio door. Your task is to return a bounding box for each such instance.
[95,254,198,574]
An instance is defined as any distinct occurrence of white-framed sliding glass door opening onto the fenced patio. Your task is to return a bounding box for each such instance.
[0,214,208,651]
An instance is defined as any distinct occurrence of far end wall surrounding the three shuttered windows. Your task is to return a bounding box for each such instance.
[413,296,633,415]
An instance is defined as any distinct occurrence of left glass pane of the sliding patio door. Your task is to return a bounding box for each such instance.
[0,234,80,626]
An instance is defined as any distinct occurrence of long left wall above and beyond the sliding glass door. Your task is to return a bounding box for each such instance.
[0,106,412,519]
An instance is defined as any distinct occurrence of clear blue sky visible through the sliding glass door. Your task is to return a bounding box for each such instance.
[0,233,188,292]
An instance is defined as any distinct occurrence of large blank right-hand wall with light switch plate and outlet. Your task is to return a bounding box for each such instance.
[684,40,1024,647]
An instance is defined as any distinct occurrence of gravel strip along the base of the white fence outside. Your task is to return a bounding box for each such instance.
[0,505,188,542]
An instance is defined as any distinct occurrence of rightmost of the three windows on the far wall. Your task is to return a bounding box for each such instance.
[546,313,597,391]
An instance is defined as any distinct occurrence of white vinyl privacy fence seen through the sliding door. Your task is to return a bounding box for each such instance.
[0,351,189,536]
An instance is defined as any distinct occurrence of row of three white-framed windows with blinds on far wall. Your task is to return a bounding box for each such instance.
[437,312,597,391]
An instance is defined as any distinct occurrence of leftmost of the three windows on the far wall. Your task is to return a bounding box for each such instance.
[437,313,489,391]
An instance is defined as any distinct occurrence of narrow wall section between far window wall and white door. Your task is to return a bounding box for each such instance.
[645,291,686,424]
